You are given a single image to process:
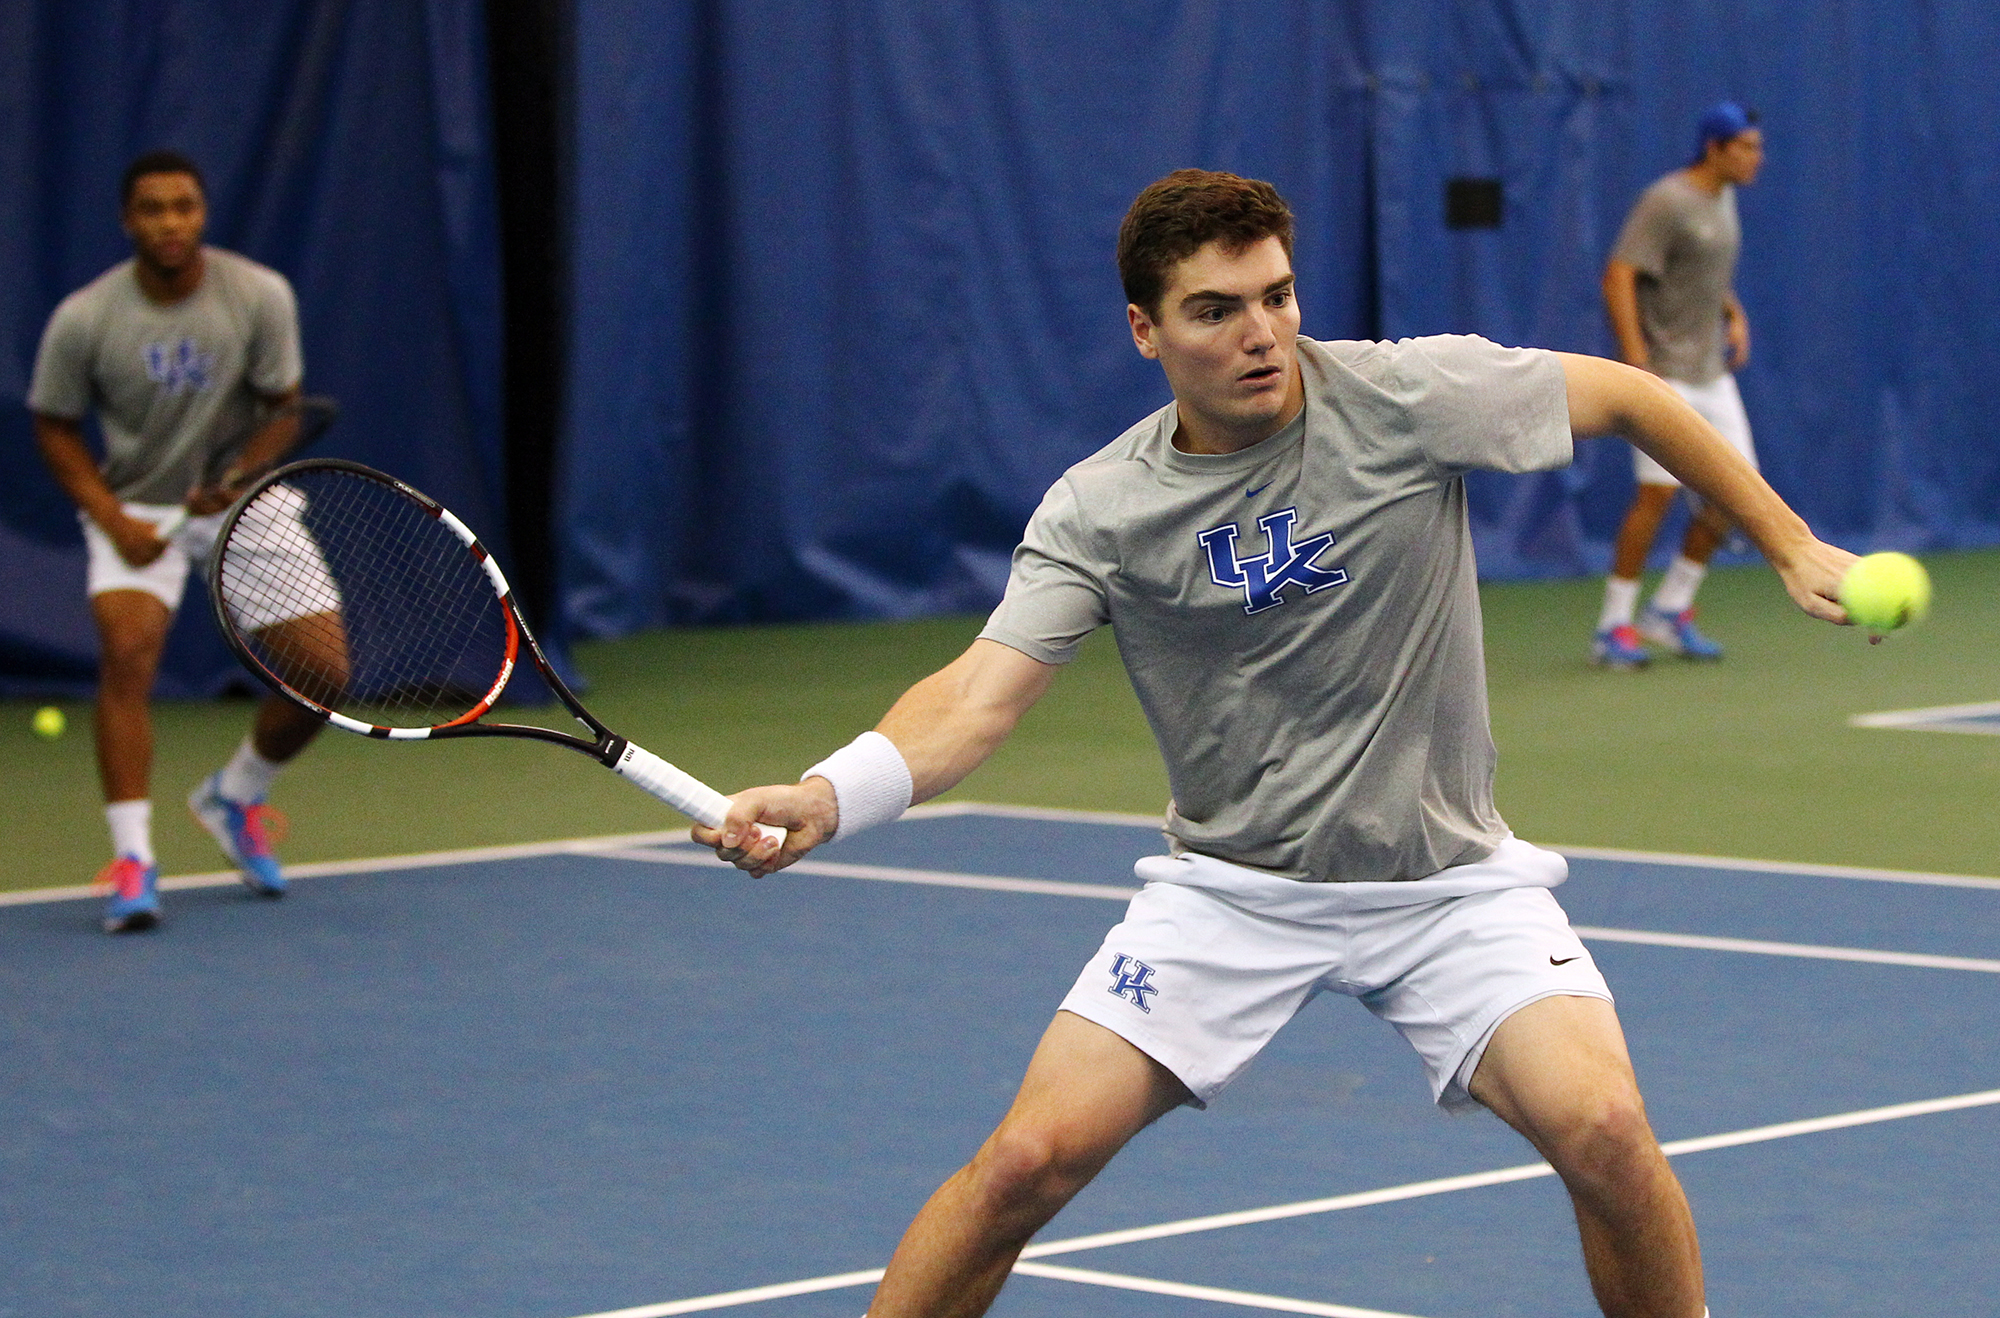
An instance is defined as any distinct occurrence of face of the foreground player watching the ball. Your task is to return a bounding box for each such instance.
[1126,238,1298,440]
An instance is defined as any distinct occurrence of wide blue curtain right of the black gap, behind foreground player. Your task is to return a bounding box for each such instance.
[560,0,2000,636]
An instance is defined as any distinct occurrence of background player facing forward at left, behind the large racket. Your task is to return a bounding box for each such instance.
[28,152,320,932]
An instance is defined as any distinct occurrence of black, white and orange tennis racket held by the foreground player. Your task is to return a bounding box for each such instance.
[208,458,782,840]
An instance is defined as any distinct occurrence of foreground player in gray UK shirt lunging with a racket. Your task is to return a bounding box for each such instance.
[694,170,1852,1318]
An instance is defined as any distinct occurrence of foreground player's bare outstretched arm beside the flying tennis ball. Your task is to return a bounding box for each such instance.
[1556,352,1854,622]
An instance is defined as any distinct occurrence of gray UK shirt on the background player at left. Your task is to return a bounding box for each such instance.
[28,248,302,504]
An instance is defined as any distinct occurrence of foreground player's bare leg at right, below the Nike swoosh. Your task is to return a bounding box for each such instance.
[1470,998,1704,1318]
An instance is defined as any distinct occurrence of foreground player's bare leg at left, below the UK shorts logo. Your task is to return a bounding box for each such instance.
[868,1012,1188,1318]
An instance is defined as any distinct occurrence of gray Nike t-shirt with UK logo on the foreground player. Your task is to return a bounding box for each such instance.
[982,336,1572,882]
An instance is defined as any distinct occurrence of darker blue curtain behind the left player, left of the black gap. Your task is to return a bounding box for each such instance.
[0,0,504,694]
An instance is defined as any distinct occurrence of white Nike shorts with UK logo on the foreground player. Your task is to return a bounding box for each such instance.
[1062,838,1612,1108]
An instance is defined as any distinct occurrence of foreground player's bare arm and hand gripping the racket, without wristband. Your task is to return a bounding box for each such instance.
[694,640,1056,874]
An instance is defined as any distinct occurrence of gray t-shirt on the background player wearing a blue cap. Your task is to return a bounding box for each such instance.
[1612,170,1744,384]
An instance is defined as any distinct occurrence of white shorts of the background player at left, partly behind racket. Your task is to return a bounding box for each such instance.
[76,496,340,632]
